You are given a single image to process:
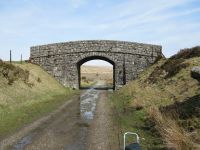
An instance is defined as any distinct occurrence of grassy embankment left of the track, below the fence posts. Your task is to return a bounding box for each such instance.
[0,61,75,140]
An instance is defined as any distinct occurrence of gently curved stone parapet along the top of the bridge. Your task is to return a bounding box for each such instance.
[31,40,162,58]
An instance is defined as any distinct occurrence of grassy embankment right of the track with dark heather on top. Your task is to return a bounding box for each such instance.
[112,47,200,150]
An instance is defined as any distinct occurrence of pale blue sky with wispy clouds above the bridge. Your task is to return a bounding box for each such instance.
[0,0,200,65]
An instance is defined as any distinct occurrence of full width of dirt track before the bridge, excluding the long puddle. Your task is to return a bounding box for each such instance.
[1,83,119,150]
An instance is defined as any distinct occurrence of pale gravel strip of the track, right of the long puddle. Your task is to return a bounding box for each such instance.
[86,91,120,150]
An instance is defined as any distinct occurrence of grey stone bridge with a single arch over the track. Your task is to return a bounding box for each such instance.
[30,40,162,89]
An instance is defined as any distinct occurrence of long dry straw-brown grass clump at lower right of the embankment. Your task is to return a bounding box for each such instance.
[148,106,195,150]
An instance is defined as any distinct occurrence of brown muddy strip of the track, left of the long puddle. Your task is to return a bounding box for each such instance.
[12,95,84,150]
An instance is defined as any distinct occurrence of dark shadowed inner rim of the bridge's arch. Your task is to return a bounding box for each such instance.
[77,56,115,90]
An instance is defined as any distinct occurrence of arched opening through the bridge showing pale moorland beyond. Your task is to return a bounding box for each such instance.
[77,56,115,89]
